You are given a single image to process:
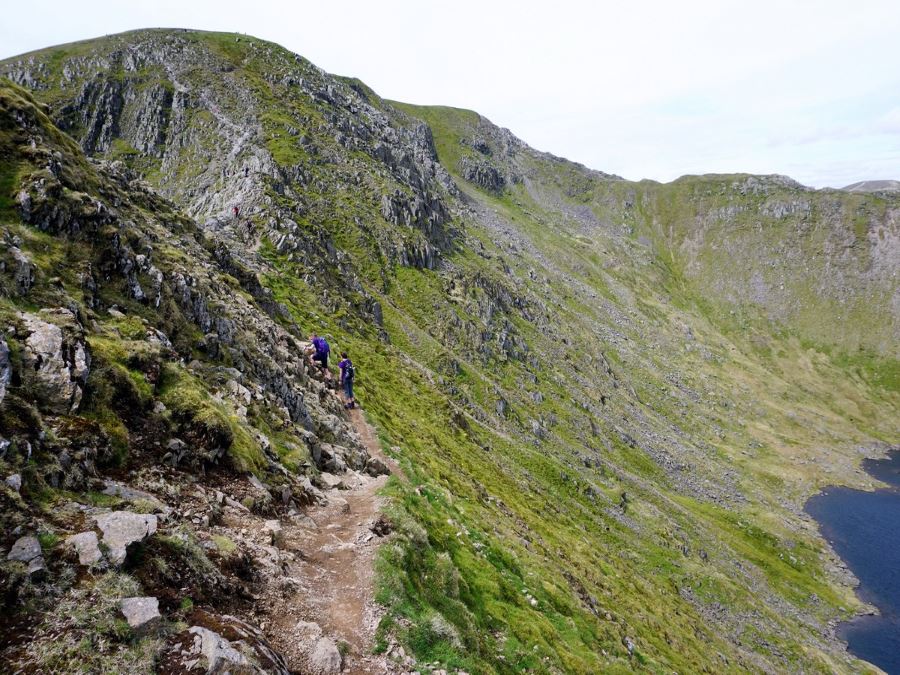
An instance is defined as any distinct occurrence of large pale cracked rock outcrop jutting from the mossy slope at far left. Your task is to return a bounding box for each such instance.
[19,309,91,413]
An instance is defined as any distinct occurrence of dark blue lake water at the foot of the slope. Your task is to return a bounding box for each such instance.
[806,452,900,675]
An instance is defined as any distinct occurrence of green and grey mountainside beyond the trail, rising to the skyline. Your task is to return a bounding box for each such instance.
[0,31,898,672]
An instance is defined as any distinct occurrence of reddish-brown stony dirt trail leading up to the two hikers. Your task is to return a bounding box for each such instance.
[265,409,398,674]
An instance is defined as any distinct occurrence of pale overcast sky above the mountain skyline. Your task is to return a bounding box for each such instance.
[0,0,900,187]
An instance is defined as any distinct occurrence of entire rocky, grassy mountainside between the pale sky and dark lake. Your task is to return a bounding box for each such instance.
[0,30,900,673]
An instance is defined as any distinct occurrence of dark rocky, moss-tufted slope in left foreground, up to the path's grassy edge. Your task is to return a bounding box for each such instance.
[0,82,410,672]
